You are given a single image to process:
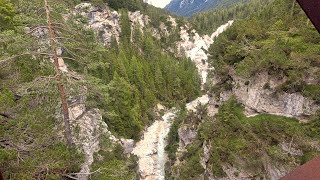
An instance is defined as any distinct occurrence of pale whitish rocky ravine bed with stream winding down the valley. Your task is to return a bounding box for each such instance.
[132,21,233,180]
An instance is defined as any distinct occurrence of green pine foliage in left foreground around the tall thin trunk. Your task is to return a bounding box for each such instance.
[0,0,142,179]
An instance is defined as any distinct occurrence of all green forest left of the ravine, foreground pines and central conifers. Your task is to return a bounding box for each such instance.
[0,0,194,179]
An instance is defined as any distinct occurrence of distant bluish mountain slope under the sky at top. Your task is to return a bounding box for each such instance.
[165,0,246,16]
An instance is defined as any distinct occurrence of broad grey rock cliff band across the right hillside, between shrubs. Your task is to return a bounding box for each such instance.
[220,72,320,120]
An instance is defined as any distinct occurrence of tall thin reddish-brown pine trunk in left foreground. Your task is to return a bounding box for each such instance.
[44,0,73,146]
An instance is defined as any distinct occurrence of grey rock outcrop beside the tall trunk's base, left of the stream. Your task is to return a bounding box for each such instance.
[69,87,127,180]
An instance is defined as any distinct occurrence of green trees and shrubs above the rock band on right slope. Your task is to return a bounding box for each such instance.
[209,0,320,96]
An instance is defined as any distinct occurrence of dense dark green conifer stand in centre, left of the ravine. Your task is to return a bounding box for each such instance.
[81,29,200,139]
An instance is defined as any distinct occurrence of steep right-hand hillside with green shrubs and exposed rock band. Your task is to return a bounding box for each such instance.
[167,0,320,179]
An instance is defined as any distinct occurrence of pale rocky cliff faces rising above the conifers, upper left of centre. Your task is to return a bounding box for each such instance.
[73,3,177,46]
